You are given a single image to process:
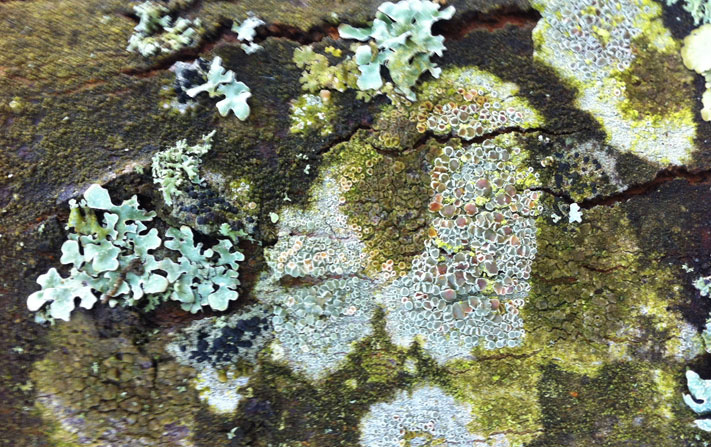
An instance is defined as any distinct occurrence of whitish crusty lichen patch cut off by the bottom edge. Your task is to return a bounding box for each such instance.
[360,385,508,447]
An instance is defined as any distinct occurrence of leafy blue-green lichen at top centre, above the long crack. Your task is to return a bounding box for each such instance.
[338,0,454,100]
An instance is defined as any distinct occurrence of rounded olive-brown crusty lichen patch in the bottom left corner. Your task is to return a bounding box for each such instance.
[31,315,199,447]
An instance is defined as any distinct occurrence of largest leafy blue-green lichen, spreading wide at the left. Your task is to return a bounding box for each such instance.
[27,185,244,322]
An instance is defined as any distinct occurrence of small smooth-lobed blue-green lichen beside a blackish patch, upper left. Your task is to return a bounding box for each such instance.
[186,56,252,121]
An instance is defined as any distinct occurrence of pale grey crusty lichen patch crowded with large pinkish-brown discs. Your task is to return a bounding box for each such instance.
[382,137,540,362]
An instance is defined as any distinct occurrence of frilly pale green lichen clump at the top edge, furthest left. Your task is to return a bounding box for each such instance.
[126,1,204,57]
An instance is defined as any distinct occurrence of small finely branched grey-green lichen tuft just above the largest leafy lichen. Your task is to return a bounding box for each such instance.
[151,130,215,206]
